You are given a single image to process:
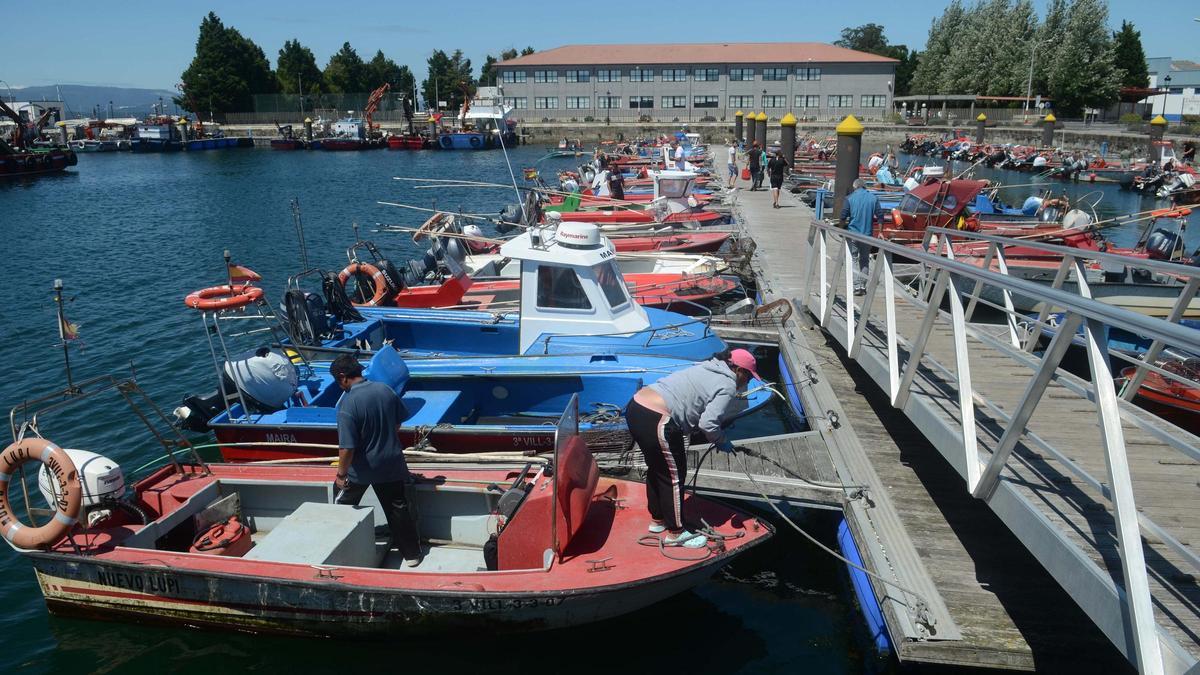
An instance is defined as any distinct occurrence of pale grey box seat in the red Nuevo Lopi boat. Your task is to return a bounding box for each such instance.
[242,502,376,567]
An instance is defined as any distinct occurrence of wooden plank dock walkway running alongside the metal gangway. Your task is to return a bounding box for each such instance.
[719,155,1129,673]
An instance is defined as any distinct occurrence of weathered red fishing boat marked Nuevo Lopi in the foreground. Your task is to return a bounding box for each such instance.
[0,383,773,639]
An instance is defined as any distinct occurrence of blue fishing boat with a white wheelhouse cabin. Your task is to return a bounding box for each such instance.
[283,219,725,360]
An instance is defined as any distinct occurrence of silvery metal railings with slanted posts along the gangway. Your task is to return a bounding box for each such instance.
[803,220,1200,673]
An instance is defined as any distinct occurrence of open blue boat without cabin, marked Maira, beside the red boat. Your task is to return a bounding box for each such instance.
[176,345,770,461]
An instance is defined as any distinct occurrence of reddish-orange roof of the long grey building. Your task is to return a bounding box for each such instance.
[496,42,898,67]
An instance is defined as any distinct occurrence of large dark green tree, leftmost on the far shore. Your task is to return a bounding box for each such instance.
[175,12,278,114]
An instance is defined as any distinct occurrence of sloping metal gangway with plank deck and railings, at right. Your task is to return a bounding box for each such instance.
[797,220,1200,673]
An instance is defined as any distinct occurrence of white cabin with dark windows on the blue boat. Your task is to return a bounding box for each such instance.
[500,222,650,353]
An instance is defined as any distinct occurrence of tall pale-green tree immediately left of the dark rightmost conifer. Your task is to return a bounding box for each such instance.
[1048,0,1121,115]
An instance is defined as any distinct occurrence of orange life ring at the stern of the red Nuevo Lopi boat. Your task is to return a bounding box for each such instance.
[0,437,83,549]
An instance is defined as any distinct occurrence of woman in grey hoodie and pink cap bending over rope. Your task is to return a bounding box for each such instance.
[625,350,758,548]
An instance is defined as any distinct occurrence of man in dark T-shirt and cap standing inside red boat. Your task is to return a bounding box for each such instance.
[329,354,421,567]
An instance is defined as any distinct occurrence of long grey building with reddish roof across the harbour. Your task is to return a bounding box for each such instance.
[496,42,896,123]
